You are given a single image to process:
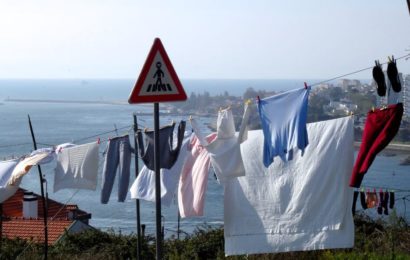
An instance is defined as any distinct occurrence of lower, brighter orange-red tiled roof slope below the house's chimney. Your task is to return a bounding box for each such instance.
[3,218,75,245]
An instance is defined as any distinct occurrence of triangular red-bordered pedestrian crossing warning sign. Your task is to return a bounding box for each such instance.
[128,38,187,104]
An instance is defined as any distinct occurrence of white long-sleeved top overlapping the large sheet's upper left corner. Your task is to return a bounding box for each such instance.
[191,106,250,183]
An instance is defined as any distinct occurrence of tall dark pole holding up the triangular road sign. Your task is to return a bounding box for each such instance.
[154,103,162,260]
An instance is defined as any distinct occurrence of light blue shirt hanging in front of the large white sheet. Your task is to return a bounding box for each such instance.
[258,88,310,167]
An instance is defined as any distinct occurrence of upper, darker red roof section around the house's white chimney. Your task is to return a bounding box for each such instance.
[3,188,91,219]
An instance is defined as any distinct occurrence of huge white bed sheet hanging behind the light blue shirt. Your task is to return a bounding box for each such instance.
[224,117,354,255]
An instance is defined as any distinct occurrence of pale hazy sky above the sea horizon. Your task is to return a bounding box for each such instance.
[0,0,410,79]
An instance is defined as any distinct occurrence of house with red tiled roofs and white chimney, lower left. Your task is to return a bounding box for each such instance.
[0,188,93,245]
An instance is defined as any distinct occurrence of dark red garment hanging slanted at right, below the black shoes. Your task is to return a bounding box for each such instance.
[350,103,403,188]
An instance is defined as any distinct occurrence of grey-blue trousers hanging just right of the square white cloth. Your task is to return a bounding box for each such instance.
[101,135,131,204]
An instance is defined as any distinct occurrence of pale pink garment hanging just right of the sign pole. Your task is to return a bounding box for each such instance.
[178,133,216,218]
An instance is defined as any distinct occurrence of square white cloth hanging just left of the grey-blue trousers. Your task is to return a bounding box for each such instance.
[54,142,99,192]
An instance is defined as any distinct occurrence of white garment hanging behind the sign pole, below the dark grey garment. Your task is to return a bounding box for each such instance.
[130,132,191,207]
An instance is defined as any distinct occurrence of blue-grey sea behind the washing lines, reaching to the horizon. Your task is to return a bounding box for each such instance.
[0,79,410,237]
